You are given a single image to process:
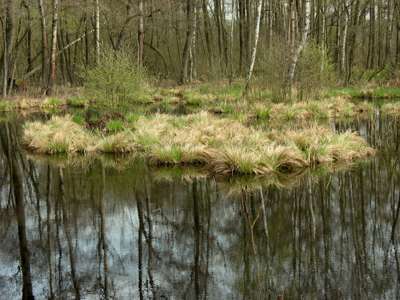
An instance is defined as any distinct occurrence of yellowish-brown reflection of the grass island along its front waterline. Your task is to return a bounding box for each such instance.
[28,148,368,195]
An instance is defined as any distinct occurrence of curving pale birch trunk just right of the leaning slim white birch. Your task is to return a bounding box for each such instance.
[287,0,311,93]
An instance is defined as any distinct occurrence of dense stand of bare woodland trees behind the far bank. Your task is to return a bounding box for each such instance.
[0,0,400,96]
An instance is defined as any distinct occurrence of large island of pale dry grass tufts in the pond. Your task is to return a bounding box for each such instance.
[23,112,374,175]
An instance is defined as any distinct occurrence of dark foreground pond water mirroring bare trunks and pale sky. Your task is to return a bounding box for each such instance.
[0,115,400,299]
